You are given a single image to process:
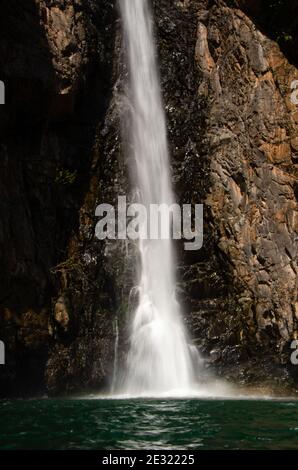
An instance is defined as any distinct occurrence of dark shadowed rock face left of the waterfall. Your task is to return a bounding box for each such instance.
[0,0,115,395]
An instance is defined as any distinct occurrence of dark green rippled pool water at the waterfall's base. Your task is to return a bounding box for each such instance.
[0,399,298,450]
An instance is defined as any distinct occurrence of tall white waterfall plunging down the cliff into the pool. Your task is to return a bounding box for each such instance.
[119,0,194,395]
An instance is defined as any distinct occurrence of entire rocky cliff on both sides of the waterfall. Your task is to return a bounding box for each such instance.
[0,0,298,395]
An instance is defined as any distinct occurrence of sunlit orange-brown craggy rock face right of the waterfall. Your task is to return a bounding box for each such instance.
[179,2,298,390]
